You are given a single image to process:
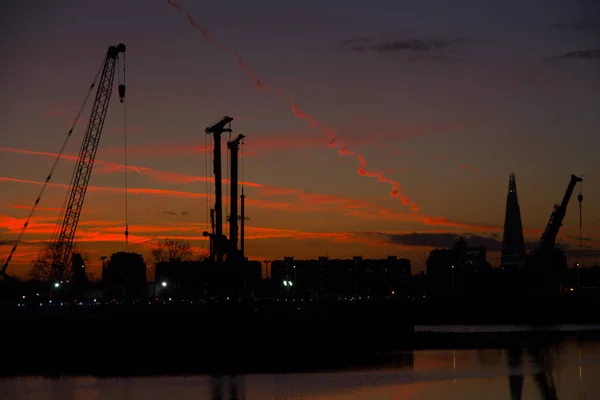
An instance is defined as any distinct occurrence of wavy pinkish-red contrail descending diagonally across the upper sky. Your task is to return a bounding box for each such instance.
[167,0,419,212]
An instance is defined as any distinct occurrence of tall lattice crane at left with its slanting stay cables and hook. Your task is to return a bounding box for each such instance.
[0,43,129,281]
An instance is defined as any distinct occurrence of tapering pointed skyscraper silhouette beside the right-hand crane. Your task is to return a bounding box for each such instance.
[501,173,525,268]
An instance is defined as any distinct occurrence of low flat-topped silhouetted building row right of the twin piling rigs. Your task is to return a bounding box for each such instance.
[269,256,411,297]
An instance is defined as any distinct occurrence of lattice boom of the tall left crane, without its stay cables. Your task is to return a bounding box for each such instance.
[51,43,126,280]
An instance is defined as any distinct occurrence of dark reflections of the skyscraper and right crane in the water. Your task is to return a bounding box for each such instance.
[506,342,560,400]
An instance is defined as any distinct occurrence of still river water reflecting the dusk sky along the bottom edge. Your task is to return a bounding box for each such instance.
[0,332,600,400]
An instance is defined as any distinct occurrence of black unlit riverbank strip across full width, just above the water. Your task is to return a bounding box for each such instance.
[0,300,600,376]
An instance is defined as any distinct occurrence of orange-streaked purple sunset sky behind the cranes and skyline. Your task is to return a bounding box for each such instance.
[0,0,600,275]
